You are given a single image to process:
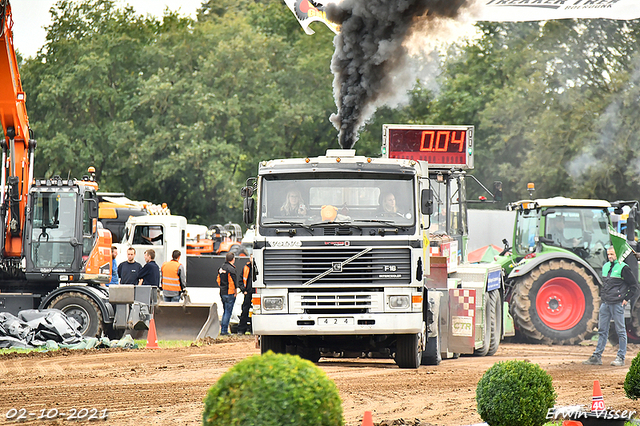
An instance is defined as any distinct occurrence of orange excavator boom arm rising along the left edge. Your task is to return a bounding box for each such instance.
[0,0,36,258]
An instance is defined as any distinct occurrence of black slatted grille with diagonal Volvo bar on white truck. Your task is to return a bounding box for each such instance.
[263,247,411,286]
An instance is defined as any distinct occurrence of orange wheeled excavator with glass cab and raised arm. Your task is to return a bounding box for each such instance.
[0,0,152,336]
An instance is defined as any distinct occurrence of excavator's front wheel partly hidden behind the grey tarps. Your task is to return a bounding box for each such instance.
[47,291,104,337]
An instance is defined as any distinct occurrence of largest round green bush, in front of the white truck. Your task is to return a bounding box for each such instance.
[202,351,343,426]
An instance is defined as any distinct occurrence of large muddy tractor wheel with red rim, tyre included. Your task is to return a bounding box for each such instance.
[511,260,600,345]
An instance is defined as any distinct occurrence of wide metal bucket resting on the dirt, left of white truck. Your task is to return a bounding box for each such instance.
[153,296,220,340]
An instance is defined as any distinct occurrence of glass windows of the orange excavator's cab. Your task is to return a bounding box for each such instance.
[31,192,77,268]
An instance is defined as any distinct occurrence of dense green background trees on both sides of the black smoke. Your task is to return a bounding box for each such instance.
[20,0,640,225]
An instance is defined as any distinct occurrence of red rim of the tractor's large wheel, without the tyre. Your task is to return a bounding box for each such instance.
[536,277,586,330]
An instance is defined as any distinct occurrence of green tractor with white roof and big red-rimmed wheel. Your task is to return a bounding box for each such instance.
[496,194,640,344]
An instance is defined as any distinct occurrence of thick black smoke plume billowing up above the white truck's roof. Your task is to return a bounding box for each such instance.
[325,0,472,149]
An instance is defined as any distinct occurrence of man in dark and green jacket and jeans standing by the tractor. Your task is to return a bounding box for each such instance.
[583,247,638,367]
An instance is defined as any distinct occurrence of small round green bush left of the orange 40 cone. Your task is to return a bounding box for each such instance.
[476,360,557,426]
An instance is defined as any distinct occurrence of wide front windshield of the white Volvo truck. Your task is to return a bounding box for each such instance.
[259,174,416,226]
